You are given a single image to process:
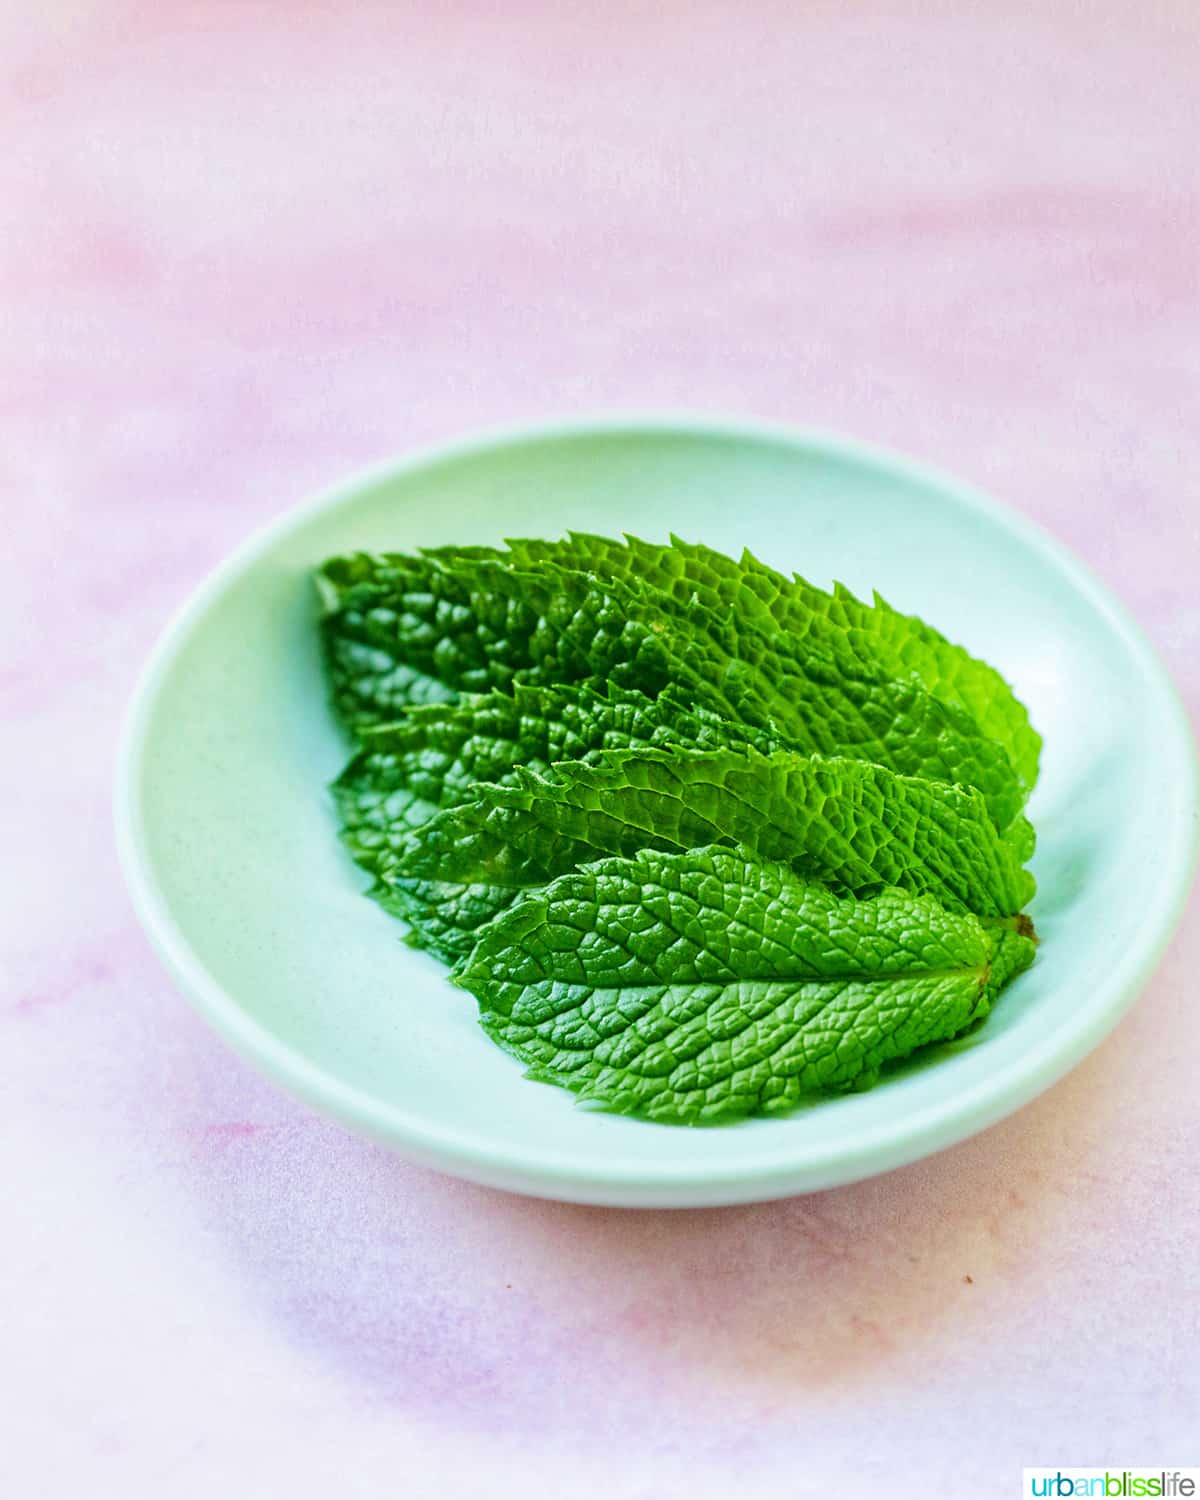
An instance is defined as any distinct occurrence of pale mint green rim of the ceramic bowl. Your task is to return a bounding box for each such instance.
[114,411,1200,1206]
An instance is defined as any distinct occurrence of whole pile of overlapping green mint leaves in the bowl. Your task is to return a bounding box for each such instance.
[317,534,1041,1125]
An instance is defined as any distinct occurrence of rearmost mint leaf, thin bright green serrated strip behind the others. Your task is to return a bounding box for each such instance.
[428,531,1041,795]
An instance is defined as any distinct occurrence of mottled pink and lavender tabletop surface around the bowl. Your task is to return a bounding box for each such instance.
[0,0,1200,1500]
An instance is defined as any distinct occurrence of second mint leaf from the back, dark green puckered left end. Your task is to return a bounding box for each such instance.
[320,554,1026,828]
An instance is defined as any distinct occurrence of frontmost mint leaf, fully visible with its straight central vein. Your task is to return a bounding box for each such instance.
[455,848,1034,1125]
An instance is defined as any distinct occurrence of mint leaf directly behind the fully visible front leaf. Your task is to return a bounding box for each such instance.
[379,747,1034,959]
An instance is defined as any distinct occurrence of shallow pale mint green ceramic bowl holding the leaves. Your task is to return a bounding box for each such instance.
[117,420,1197,1205]
